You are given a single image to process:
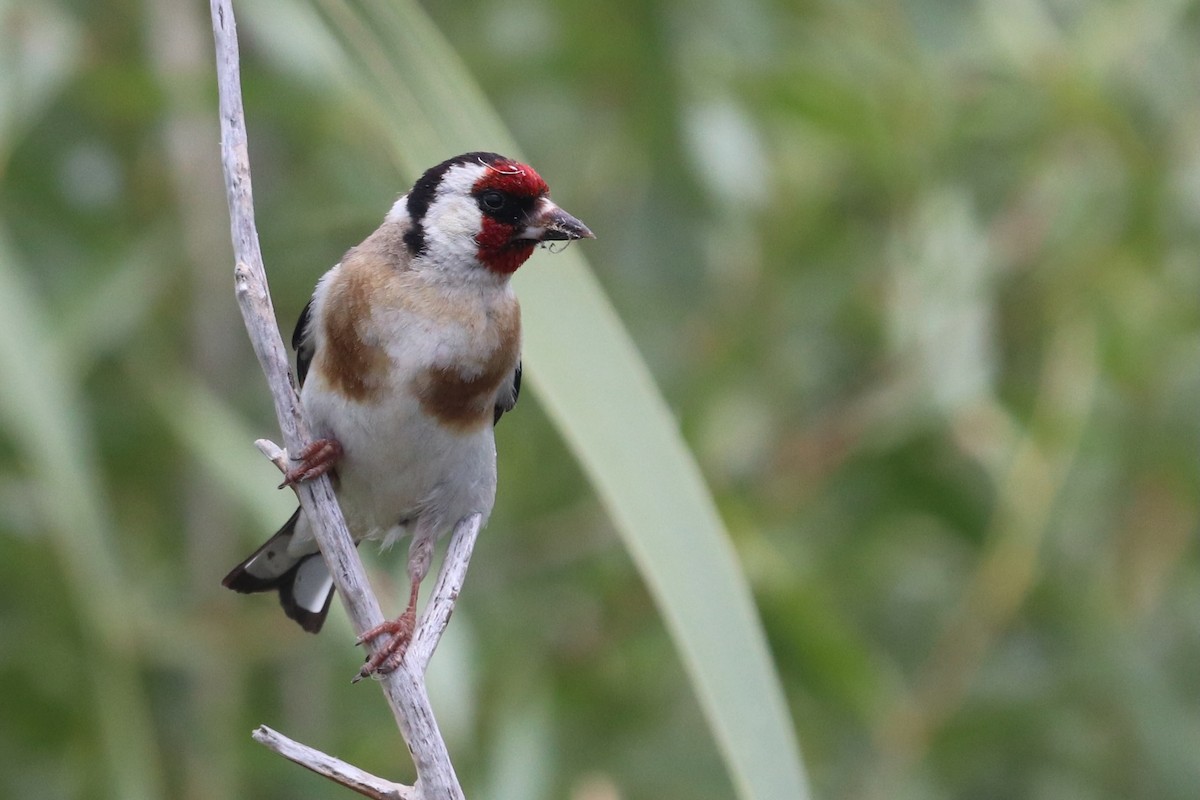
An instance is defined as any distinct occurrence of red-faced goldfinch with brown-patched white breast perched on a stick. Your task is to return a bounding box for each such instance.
[222,152,595,676]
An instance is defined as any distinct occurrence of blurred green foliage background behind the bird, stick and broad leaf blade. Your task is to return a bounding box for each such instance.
[0,0,1200,800]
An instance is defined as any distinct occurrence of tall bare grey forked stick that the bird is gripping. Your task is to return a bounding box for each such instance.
[210,0,480,800]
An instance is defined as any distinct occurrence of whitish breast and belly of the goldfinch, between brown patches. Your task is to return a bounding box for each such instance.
[296,260,520,547]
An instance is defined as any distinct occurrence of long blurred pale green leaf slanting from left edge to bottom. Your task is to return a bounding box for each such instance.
[0,231,163,800]
